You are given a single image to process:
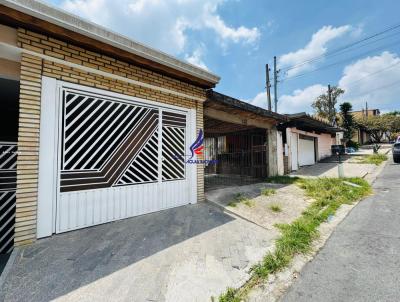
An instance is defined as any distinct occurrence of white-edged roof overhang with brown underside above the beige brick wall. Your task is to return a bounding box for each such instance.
[0,0,220,88]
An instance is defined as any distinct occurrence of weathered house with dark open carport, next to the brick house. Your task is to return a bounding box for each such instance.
[204,90,287,189]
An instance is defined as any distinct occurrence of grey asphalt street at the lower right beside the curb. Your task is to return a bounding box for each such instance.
[281,160,400,302]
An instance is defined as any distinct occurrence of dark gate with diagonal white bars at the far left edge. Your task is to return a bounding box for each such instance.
[0,142,17,254]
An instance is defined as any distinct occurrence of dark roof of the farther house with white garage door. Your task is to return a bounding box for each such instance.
[281,112,343,134]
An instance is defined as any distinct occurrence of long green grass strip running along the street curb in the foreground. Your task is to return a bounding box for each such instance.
[219,178,371,302]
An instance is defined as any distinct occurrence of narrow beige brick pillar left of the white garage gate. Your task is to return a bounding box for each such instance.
[15,54,42,245]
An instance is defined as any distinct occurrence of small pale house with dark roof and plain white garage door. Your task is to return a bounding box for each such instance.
[278,112,343,173]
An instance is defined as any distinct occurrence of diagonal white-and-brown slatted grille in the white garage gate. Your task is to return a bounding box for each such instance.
[60,89,187,192]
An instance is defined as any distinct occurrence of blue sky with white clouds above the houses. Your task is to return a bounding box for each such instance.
[47,0,400,113]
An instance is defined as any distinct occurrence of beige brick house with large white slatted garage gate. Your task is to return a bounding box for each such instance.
[0,0,219,252]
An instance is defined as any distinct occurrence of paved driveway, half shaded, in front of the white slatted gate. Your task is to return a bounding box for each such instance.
[0,203,276,301]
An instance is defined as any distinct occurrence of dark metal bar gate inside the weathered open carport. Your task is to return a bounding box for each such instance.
[204,131,268,190]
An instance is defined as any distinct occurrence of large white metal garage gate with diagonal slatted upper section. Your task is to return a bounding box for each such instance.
[38,80,196,235]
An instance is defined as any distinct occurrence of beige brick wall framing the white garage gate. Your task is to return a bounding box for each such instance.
[15,28,206,245]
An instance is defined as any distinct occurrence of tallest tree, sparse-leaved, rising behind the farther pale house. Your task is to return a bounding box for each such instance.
[312,86,344,123]
